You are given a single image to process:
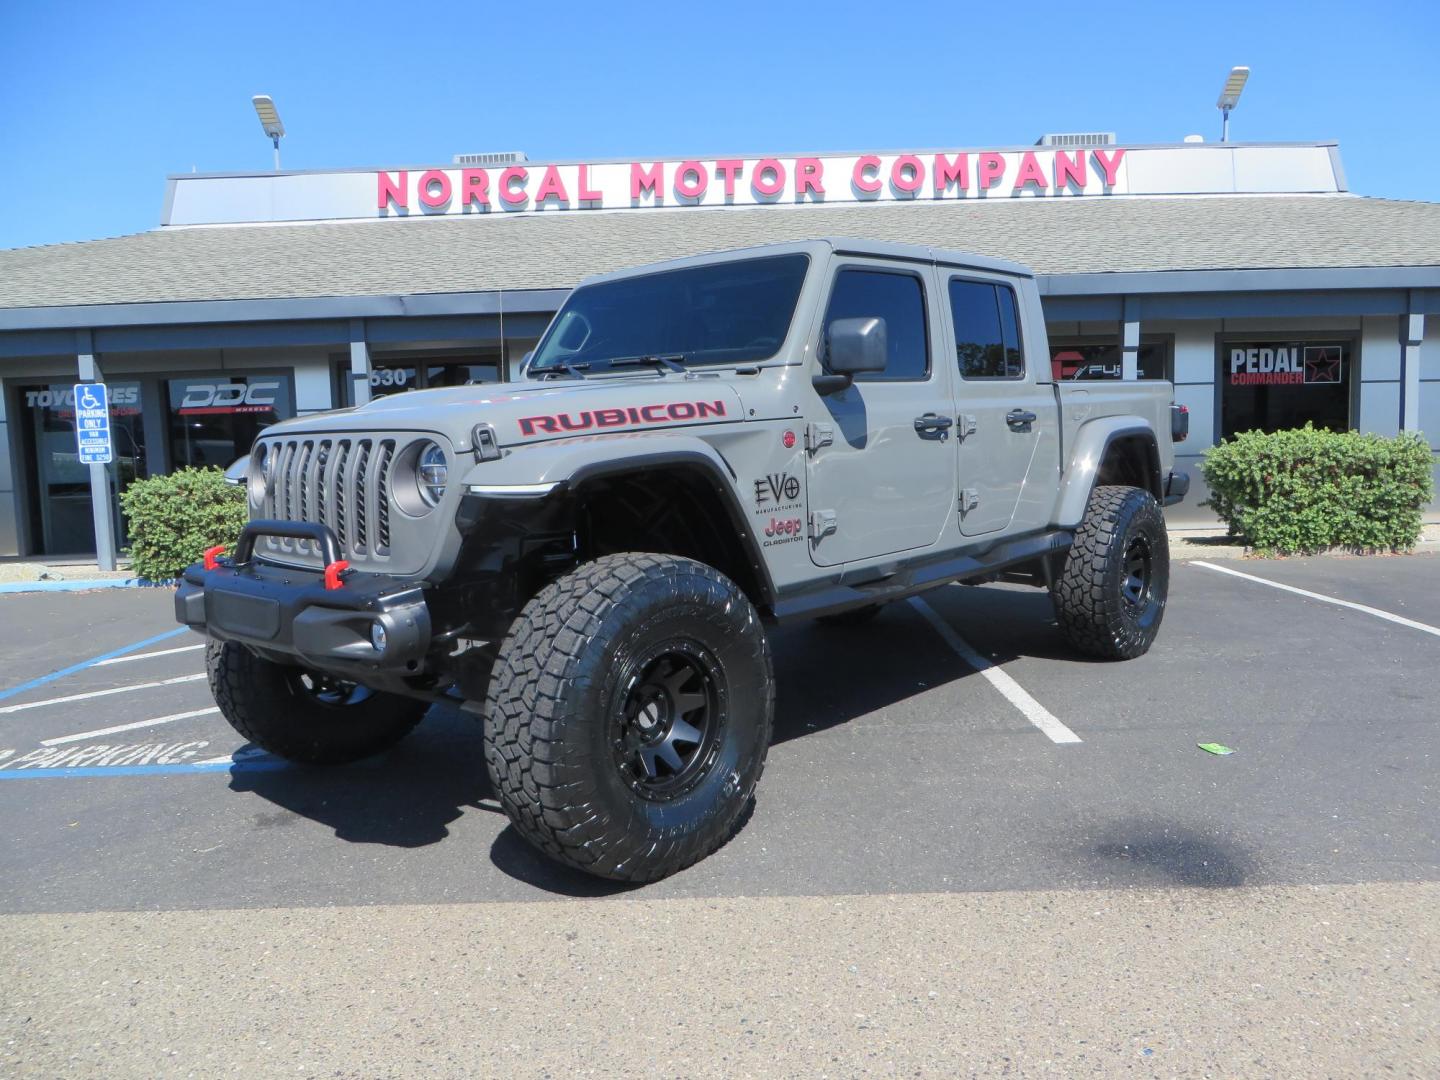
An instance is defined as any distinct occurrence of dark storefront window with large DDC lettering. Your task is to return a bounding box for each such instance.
[167,374,295,468]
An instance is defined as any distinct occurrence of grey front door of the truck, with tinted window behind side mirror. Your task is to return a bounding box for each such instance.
[808,259,955,566]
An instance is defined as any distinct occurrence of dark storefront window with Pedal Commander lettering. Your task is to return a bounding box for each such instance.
[1220,340,1352,438]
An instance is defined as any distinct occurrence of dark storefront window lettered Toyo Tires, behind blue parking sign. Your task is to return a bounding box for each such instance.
[20,383,148,554]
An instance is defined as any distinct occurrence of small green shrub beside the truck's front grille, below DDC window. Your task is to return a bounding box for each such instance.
[120,468,246,582]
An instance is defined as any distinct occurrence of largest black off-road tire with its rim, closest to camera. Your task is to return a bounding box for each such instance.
[484,553,775,881]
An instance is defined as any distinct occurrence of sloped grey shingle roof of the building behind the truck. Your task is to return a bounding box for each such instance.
[0,194,1440,308]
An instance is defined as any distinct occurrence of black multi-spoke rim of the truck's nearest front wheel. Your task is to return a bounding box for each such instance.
[611,641,726,802]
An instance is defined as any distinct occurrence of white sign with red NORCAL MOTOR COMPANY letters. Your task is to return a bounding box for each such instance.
[374,147,1125,215]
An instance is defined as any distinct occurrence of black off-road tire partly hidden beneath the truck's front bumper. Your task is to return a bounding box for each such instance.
[204,641,428,765]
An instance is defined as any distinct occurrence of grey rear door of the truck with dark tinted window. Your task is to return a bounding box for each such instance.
[940,275,1060,536]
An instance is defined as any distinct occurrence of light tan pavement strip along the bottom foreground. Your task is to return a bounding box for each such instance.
[0,883,1440,1080]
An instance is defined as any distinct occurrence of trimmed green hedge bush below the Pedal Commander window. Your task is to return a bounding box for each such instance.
[1200,423,1434,554]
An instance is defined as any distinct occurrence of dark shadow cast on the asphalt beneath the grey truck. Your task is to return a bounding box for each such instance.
[221,589,1073,897]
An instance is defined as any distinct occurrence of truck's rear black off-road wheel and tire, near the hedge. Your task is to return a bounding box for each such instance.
[1050,487,1169,660]
